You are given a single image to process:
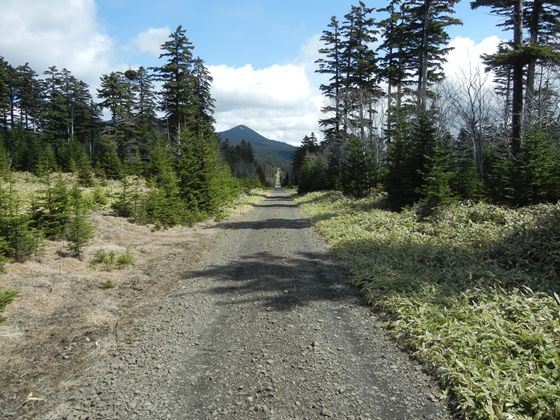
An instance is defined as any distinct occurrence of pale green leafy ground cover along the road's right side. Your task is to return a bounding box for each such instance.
[296,192,560,419]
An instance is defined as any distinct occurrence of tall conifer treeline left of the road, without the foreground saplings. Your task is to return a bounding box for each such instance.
[0,26,265,230]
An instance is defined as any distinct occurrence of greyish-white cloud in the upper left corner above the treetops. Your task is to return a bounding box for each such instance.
[0,0,113,85]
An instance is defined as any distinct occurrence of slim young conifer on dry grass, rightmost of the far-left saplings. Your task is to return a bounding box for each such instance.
[64,184,95,258]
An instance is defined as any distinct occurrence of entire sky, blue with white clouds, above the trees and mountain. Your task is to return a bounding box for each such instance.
[0,0,507,144]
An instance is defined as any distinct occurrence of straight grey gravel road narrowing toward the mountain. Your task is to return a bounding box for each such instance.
[47,190,451,420]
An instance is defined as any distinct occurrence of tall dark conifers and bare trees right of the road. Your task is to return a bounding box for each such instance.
[293,0,560,211]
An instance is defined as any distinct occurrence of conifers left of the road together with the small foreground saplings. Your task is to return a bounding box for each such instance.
[0,26,265,263]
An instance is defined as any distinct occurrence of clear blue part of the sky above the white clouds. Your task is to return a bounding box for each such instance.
[97,0,500,68]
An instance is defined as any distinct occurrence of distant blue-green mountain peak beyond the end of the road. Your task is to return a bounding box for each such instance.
[218,125,296,161]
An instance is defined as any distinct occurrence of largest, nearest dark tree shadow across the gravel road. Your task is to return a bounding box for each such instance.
[184,252,361,311]
